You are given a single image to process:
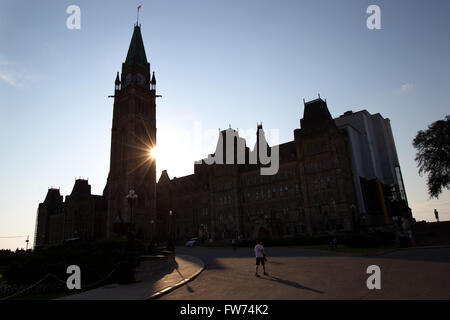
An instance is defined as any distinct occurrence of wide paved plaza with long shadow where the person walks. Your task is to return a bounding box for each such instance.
[160,247,450,300]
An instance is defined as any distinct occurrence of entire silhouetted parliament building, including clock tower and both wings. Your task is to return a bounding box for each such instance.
[35,25,411,247]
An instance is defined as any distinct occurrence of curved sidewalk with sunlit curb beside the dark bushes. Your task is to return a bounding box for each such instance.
[61,254,205,300]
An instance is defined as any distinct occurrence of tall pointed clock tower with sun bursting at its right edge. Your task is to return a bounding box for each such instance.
[105,25,156,240]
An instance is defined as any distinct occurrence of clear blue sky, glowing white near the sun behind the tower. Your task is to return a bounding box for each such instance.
[0,0,450,249]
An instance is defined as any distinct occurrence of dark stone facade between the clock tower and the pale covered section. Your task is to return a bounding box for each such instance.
[157,99,358,239]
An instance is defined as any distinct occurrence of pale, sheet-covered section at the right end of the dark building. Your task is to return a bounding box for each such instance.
[335,110,411,225]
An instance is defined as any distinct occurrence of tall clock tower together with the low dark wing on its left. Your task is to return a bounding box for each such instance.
[35,25,157,247]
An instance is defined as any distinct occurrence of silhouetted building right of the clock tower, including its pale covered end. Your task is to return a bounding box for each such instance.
[157,98,411,239]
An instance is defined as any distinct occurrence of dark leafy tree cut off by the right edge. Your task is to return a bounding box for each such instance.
[413,115,450,198]
